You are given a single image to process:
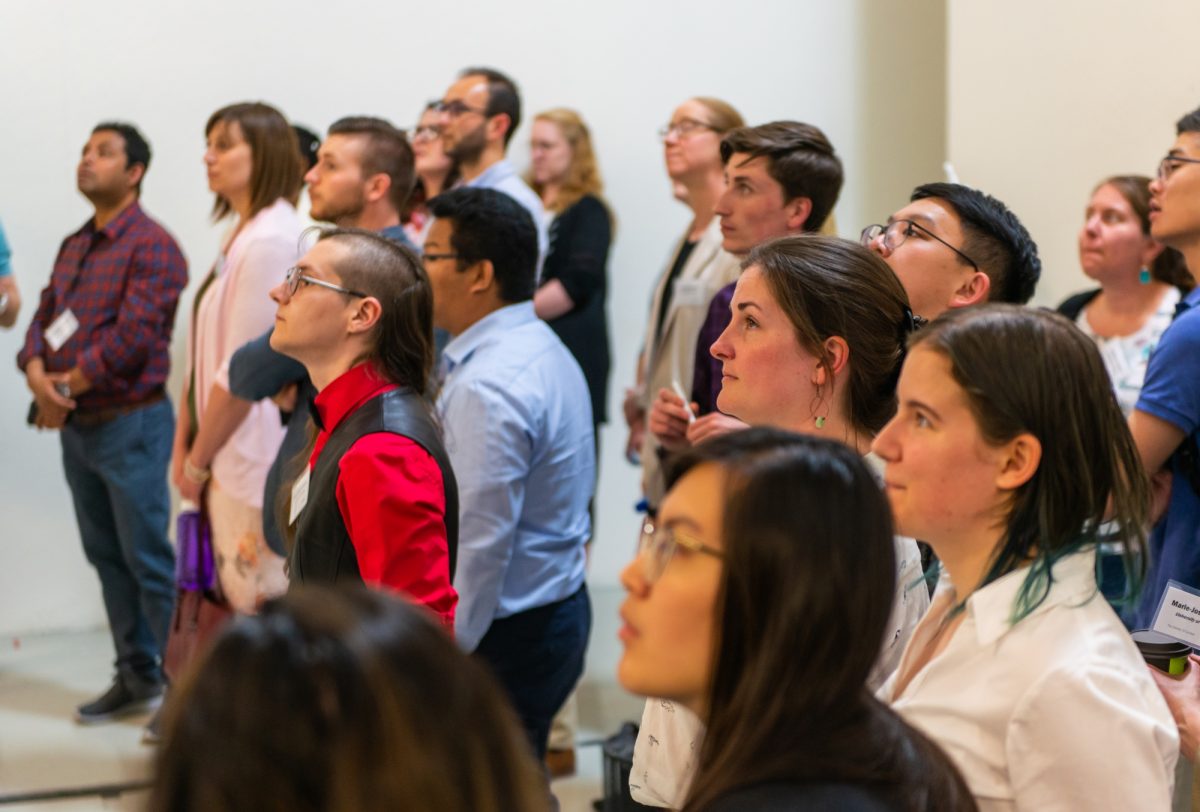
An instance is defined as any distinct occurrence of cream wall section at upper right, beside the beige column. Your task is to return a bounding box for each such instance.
[947,0,1200,306]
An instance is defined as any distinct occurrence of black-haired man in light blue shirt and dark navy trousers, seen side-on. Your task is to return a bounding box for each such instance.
[425,188,595,757]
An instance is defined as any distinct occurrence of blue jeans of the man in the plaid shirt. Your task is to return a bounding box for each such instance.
[62,401,175,686]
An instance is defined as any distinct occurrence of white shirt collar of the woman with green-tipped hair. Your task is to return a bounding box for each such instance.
[966,548,1097,645]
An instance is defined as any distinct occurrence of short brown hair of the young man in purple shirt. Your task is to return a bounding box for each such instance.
[721,121,844,231]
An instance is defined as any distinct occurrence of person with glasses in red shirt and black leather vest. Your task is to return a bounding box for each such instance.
[271,229,458,628]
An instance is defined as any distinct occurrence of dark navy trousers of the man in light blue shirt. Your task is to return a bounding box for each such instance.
[475,585,592,759]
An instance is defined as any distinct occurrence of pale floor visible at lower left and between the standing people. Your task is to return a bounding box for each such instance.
[0,589,641,812]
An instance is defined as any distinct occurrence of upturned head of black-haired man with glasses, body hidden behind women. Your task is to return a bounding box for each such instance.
[862,184,1042,319]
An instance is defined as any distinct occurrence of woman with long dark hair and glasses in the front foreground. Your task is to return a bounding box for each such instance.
[618,428,974,812]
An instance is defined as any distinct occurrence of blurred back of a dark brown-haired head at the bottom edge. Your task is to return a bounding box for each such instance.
[149,587,548,812]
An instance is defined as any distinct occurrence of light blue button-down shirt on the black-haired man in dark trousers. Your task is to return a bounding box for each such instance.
[438,301,595,651]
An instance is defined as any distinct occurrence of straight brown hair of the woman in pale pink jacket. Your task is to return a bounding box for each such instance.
[204,102,304,219]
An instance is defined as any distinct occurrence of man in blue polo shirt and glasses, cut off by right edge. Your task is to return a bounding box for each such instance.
[1129,109,1200,628]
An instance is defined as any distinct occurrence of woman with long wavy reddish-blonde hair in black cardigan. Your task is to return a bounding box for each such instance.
[526,108,612,443]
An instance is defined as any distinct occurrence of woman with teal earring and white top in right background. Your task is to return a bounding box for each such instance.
[1058,175,1193,416]
